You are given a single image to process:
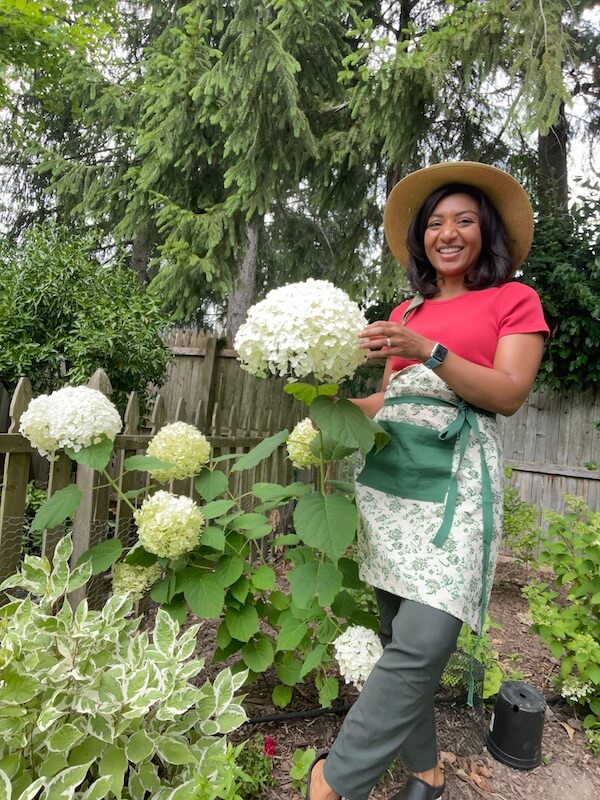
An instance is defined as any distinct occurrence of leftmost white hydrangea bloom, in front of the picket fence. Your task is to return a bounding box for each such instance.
[19,386,122,457]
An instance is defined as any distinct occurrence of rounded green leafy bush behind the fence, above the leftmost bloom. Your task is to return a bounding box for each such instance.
[0,226,169,405]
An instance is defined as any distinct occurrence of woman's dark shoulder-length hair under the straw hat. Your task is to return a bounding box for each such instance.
[406,183,512,297]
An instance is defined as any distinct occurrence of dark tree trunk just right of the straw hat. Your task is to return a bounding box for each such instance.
[538,103,569,214]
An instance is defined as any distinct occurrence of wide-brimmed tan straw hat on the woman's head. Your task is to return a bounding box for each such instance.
[383,161,533,272]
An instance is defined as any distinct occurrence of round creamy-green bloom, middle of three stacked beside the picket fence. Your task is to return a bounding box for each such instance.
[133,492,204,558]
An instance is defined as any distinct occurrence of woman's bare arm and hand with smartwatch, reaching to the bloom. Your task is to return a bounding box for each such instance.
[360,322,544,417]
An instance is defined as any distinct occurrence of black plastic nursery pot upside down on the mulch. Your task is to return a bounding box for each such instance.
[486,681,546,769]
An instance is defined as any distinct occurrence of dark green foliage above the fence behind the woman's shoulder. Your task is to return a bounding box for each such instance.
[523,196,600,389]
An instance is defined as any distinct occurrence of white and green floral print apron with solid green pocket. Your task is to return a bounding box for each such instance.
[356,364,503,633]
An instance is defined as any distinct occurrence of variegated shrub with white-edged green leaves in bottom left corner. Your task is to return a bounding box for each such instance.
[0,537,245,800]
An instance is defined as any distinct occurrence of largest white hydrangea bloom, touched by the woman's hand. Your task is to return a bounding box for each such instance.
[234,278,366,383]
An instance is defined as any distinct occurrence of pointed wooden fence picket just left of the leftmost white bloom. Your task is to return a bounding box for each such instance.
[0,378,33,580]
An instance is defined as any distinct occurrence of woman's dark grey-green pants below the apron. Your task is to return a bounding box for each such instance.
[324,589,462,800]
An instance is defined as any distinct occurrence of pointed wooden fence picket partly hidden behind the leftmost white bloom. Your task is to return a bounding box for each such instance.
[69,369,112,608]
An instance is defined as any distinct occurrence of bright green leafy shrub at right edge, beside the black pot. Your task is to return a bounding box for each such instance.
[523,495,600,715]
